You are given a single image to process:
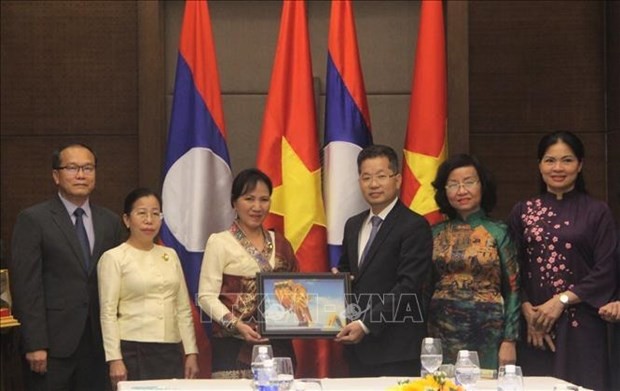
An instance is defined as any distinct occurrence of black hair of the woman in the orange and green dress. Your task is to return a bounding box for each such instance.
[433,154,497,219]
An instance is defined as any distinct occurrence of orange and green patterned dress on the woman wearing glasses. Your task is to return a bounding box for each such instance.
[428,210,520,369]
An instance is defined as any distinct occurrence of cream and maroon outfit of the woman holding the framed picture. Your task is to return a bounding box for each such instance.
[198,223,298,378]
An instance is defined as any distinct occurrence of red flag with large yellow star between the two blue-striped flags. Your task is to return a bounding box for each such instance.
[257,0,331,377]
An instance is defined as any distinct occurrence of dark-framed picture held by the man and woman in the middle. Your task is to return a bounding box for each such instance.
[257,273,350,338]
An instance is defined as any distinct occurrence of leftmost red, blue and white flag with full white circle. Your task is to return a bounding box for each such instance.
[161,1,233,377]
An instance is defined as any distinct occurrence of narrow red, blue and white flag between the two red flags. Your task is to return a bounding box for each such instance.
[323,0,372,266]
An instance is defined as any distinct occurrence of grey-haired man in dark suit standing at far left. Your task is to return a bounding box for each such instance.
[10,144,123,390]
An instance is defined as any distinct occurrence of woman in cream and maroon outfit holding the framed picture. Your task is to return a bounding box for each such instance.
[198,169,298,378]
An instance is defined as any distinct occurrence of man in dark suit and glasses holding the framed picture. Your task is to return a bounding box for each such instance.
[336,145,433,377]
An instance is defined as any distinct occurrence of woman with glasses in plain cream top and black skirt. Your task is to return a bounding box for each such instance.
[97,188,198,387]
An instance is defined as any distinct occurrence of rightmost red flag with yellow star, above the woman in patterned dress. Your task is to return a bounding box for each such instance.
[401,0,448,223]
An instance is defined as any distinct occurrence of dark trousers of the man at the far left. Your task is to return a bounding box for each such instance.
[23,321,111,391]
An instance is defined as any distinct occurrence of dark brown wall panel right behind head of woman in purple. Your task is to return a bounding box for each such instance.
[471,132,606,219]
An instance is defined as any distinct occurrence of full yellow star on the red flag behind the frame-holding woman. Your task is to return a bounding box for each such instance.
[271,137,326,252]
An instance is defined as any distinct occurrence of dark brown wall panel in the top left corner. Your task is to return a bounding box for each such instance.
[1,1,137,136]
